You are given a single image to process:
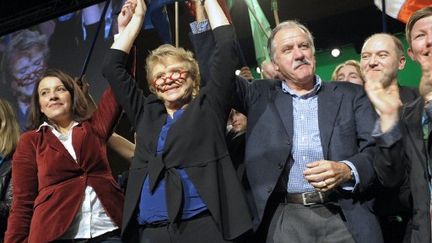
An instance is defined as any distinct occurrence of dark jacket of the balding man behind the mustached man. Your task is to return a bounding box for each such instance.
[373,86,420,243]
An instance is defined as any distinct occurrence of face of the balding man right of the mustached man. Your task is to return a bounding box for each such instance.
[360,34,405,87]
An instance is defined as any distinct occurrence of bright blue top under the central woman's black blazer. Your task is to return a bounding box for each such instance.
[138,109,207,224]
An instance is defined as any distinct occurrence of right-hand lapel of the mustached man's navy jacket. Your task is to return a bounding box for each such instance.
[318,81,343,158]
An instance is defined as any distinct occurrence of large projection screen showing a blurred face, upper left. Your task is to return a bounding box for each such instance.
[0,0,122,131]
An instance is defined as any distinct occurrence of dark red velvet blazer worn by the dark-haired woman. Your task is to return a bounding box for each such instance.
[5,89,124,242]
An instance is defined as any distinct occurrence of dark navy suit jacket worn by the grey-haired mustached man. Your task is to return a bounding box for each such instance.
[235,79,382,242]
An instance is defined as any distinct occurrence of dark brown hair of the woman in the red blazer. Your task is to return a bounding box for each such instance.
[27,69,90,130]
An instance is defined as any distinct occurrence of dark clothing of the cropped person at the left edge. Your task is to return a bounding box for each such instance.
[0,156,12,242]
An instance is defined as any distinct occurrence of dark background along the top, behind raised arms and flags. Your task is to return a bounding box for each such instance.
[0,0,404,66]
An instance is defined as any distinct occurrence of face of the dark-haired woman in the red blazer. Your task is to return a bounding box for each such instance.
[37,76,72,125]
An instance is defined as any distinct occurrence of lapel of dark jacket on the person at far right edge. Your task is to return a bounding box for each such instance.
[402,97,427,169]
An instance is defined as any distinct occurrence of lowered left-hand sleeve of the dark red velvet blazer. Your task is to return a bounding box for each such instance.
[5,132,38,243]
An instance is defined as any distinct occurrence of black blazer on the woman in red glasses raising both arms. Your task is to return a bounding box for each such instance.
[103,26,251,242]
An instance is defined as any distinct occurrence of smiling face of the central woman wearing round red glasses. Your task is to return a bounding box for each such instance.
[151,56,194,109]
